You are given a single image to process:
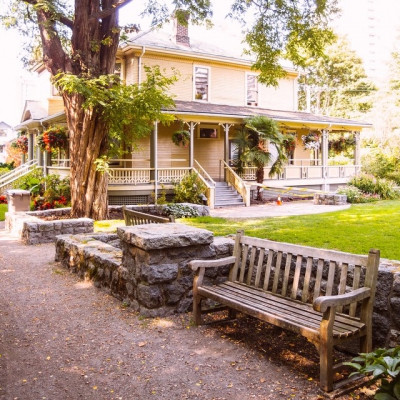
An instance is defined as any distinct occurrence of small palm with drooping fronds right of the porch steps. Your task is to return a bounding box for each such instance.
[233,116,287,200]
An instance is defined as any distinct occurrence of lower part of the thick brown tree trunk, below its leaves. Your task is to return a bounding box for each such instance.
[63,94,108,220]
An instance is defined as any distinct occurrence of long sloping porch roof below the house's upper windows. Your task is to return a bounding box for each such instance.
[164,100,372,131]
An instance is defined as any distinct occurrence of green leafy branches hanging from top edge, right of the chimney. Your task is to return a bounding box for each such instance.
[231,0,338,86]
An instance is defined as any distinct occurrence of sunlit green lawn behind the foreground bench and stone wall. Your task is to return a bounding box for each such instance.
[180,200,400,260]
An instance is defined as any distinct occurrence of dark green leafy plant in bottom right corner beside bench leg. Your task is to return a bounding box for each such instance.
[344,346,400,400]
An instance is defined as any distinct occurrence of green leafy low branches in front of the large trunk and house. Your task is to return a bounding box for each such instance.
[54,66,177,156]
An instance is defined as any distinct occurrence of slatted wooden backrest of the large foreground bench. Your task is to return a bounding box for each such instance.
[229,231,379,316]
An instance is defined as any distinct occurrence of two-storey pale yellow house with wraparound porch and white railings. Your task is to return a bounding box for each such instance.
[9,23,369,207]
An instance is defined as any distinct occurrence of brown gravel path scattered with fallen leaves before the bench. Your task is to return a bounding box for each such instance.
[0,231,376,400]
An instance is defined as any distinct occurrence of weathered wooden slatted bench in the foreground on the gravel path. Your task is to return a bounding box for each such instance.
[189,231,380,392]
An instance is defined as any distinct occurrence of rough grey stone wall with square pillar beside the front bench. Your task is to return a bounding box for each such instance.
[56,224,400,347]
